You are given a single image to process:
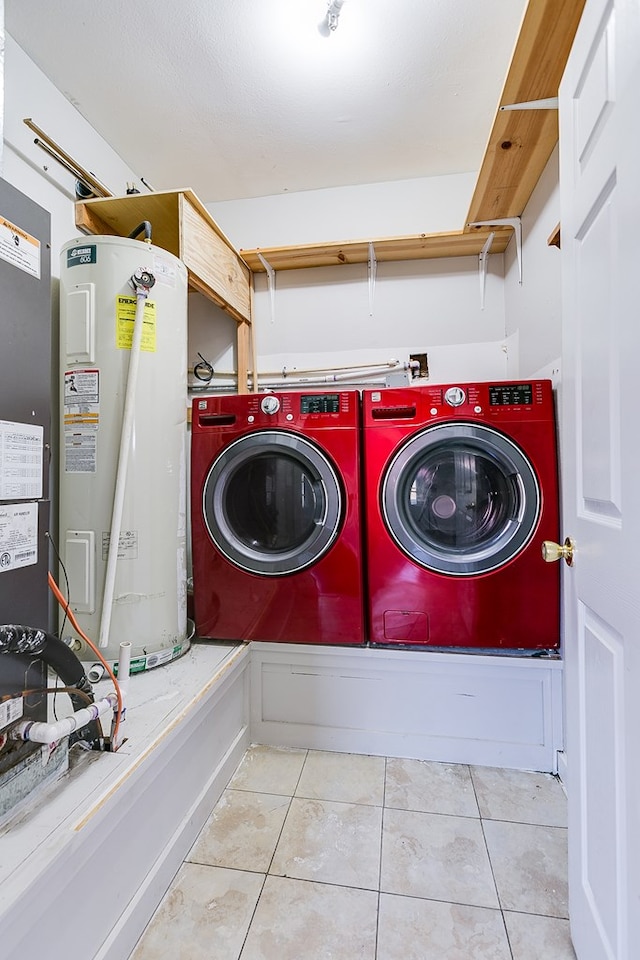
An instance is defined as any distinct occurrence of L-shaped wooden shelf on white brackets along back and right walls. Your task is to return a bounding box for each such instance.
[240,0,585,273]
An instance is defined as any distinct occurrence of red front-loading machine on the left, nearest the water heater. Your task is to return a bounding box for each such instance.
[191,390,364,644]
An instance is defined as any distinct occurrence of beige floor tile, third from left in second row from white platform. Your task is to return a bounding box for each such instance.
[380,809,498,907]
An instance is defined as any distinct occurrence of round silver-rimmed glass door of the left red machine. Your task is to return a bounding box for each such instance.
[202,430,343,576]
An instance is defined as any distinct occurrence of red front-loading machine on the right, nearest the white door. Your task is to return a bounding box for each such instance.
[363,380,560,650]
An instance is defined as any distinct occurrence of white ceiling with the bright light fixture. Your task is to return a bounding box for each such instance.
[5,0,527,203]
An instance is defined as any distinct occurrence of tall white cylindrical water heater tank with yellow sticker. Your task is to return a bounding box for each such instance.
[60,236,189,679]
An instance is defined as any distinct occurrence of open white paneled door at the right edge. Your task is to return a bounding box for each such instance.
[560,0,640,960]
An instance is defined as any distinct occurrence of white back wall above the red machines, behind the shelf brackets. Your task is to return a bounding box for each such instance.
[200,174,507,382]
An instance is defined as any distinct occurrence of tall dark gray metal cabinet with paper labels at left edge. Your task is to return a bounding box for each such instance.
[0,180,51,780]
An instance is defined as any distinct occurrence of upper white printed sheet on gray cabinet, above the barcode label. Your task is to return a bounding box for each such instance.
[0,420,44,500]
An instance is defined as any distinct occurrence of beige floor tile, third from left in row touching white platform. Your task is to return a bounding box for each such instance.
[384,759,480,817]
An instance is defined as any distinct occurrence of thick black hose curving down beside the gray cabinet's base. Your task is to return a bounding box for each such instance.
[0,623,104,750]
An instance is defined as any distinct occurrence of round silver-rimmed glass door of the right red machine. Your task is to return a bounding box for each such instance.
[381,423,540,576]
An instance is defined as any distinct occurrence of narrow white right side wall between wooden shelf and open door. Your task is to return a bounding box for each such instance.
[504,147,562,381]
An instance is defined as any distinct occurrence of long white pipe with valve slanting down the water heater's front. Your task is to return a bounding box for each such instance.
[98,269,156,647]
